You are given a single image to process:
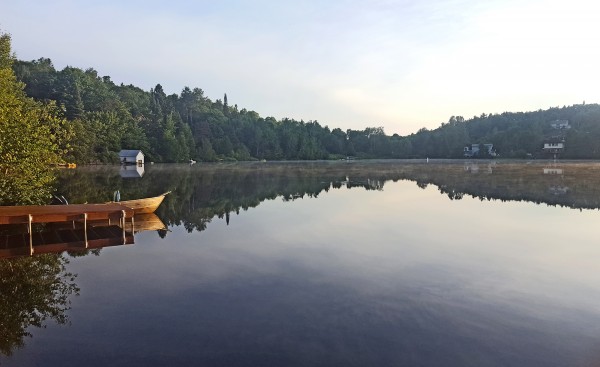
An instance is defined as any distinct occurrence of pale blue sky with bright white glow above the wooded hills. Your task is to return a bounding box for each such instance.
[0,0,600,135]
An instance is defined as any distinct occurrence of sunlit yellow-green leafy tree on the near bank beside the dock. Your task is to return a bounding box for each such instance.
[0,34,73,205]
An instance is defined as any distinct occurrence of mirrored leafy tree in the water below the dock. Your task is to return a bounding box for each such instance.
[0,254,79,355]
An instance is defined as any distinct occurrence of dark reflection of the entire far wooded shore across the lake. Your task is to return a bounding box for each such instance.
[59,161,600,236]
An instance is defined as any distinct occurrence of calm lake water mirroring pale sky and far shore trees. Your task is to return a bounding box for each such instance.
[0,161,600,367]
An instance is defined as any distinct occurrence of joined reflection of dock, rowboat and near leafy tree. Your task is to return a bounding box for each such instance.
[0,213,166,356]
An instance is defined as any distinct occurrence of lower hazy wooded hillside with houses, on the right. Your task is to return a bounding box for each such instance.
[408,104,600,159]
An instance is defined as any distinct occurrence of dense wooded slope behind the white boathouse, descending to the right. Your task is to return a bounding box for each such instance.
[13,58,388,163]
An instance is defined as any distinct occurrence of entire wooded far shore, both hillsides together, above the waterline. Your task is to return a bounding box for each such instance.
[13,58,600,163]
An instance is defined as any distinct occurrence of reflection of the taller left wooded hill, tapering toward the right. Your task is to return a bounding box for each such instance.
[59,163,385,235]
